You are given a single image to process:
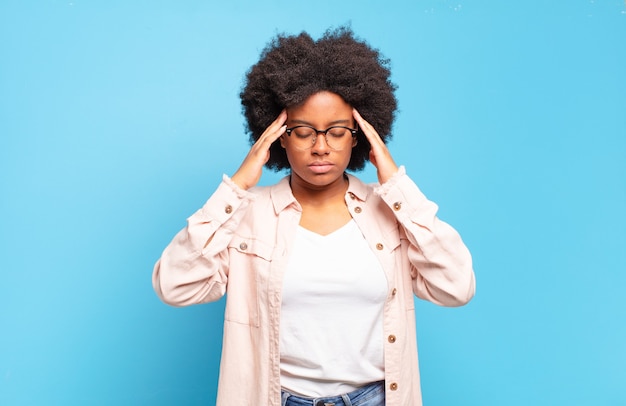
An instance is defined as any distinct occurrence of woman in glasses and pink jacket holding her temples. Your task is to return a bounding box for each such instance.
[153,28,475,406]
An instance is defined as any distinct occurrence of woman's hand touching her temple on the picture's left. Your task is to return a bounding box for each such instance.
[231,110,287,190]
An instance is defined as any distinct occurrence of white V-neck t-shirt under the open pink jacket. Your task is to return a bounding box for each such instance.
[280,220,387,397]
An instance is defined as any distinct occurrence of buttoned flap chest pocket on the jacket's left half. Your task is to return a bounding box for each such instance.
[224,235,273,327]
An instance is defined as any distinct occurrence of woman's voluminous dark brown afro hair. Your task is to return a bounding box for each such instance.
[240,27,397,171]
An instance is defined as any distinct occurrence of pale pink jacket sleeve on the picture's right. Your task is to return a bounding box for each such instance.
[375,167,476,306]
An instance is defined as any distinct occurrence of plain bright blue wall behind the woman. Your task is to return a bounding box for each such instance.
[0,0,626,406]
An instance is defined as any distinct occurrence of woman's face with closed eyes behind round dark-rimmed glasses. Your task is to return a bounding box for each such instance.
[280,91,356,188]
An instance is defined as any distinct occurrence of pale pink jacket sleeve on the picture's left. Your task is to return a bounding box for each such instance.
[152,175,255,306]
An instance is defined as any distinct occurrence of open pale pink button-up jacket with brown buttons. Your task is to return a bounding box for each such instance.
[153,167,475,406]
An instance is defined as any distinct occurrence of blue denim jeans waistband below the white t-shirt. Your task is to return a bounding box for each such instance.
[282,381,385,406]
